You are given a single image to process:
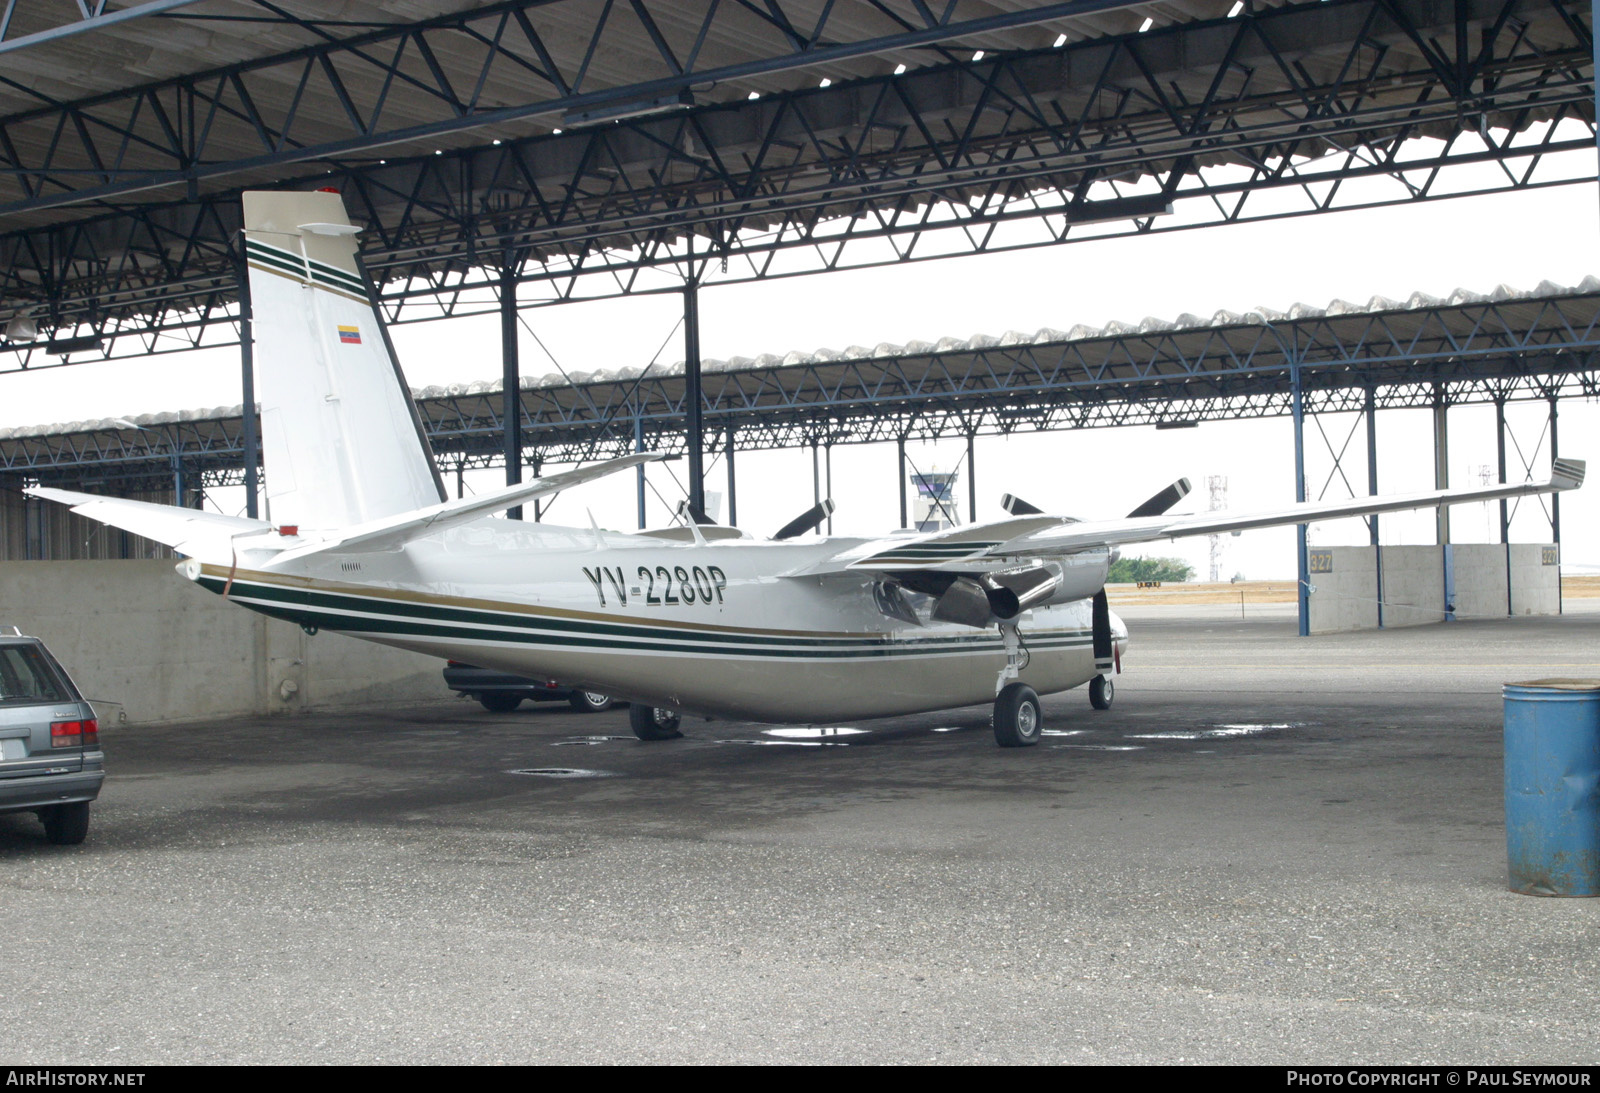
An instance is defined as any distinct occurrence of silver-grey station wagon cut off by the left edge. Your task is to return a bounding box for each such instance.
[0,627,106,845]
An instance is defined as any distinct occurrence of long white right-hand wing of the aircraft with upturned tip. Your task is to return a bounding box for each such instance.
[792,459,1584,576]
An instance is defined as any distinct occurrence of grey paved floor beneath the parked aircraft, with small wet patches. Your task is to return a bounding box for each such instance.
[0,608,1600,1064]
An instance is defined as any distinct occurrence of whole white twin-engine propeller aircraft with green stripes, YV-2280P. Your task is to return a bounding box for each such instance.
[30,192,1584,747]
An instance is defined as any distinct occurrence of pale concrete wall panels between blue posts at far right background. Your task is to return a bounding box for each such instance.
[1310,542,1560,634]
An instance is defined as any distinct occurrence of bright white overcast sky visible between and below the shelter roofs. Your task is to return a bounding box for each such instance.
[0,130,1600,578]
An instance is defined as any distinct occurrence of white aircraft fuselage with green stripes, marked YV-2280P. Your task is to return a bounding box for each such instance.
[186,520,1126,723]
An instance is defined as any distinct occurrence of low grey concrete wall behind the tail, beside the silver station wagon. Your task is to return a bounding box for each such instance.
[0,562,450,722]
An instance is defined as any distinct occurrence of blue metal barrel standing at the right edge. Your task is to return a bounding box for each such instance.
[1501,679,1600,896]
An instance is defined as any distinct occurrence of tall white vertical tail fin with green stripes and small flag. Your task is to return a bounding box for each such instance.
[243,190,445,530]
